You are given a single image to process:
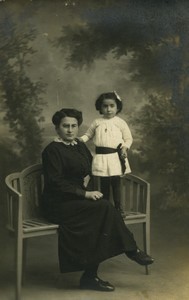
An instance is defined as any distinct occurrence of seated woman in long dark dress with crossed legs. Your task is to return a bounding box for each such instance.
[42,109,153,291]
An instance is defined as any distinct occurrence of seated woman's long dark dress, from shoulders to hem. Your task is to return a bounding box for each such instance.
[42,142,137,272]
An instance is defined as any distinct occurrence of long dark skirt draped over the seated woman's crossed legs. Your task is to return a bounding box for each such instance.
[45,199,137,273]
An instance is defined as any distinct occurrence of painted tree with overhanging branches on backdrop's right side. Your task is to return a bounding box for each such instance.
[57,0,189,206]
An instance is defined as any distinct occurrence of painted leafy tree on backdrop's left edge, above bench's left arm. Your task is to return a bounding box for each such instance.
[0,14,44,165]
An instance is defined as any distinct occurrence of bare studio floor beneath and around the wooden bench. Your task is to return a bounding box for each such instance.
[0,211,189,300]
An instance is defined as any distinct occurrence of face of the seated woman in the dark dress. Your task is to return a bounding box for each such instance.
[56,117,78,142]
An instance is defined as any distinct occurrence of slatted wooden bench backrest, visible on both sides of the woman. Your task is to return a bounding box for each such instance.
[6,164,150,231]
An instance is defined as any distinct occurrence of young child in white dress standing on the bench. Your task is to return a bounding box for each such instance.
[80,91,133,215]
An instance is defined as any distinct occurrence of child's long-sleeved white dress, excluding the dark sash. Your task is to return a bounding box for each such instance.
[81,116,133,177]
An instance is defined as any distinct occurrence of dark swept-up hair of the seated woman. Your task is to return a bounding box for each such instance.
[52,108,83,128]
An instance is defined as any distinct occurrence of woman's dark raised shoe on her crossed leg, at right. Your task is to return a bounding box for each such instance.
[126,249,154,266]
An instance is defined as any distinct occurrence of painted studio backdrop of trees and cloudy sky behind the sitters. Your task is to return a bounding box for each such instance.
[0,0,189,298]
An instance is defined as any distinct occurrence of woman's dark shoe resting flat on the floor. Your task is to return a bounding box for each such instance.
[80,276,115,292]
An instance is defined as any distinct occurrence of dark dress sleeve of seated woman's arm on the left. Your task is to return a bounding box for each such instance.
[42,149,86,197]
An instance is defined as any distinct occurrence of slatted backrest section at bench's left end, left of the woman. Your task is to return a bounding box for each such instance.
[5,164,43,232]
